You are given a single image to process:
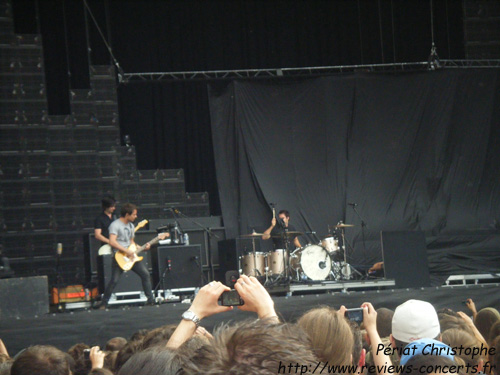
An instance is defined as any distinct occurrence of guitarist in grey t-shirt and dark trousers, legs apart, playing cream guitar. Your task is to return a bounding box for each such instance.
[96,203,163,309]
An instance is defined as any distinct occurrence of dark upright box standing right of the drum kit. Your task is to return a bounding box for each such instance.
[380,231,431,288]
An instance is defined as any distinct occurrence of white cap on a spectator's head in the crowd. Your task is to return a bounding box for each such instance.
[391,299,440,348]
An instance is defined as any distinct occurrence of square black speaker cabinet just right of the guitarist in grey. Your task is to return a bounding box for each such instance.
[151,245,202,290]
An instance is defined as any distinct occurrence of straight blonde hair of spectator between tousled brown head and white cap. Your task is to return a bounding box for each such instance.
[297,306,354,366]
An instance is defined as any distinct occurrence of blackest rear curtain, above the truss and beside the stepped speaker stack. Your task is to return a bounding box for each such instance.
[12,0,464,214]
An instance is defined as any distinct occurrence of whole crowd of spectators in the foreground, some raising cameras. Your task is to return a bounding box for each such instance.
[0,275,500,375]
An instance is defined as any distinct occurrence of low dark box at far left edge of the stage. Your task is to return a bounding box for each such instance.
[0,276,49,320]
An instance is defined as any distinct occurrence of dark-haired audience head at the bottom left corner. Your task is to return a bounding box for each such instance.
[11,345,71,375]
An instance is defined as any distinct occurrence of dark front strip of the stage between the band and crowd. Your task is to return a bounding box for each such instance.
[0,284,500,356]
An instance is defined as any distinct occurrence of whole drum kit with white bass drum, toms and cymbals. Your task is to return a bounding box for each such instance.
[239,222,354,285]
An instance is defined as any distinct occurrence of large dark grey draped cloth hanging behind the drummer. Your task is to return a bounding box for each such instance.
[209,70,500,280]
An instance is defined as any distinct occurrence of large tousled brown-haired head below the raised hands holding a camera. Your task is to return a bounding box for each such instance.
[183,320,318,375]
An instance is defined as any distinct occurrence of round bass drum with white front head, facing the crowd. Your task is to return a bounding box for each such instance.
[290,245,332,281]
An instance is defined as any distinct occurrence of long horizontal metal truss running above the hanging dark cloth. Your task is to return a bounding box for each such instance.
[118,60,500,83]
